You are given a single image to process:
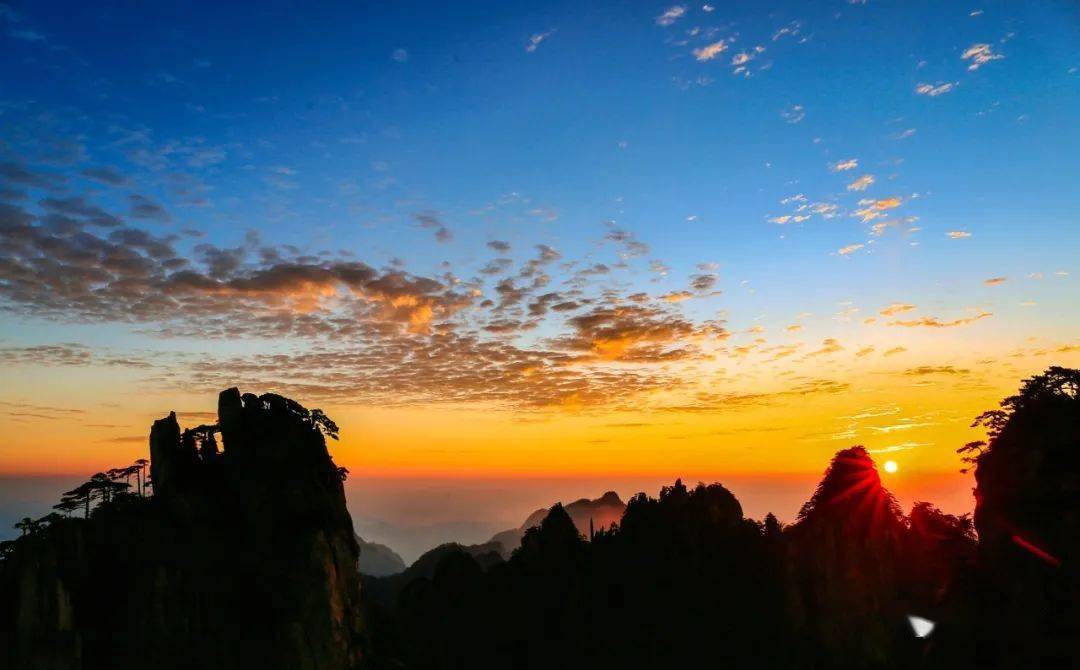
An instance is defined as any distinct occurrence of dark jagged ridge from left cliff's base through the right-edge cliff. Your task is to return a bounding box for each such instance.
[364,367,1080,670]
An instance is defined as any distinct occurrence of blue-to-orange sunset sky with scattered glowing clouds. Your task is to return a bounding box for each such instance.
[0,0,1080,553]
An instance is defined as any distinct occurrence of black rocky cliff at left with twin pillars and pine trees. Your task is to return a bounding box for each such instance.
[0,389,361,670]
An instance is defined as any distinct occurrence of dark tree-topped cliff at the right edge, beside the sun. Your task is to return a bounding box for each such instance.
[954,367,1080,668]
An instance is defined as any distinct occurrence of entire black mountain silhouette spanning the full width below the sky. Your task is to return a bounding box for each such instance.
[0,367,1080,670]
